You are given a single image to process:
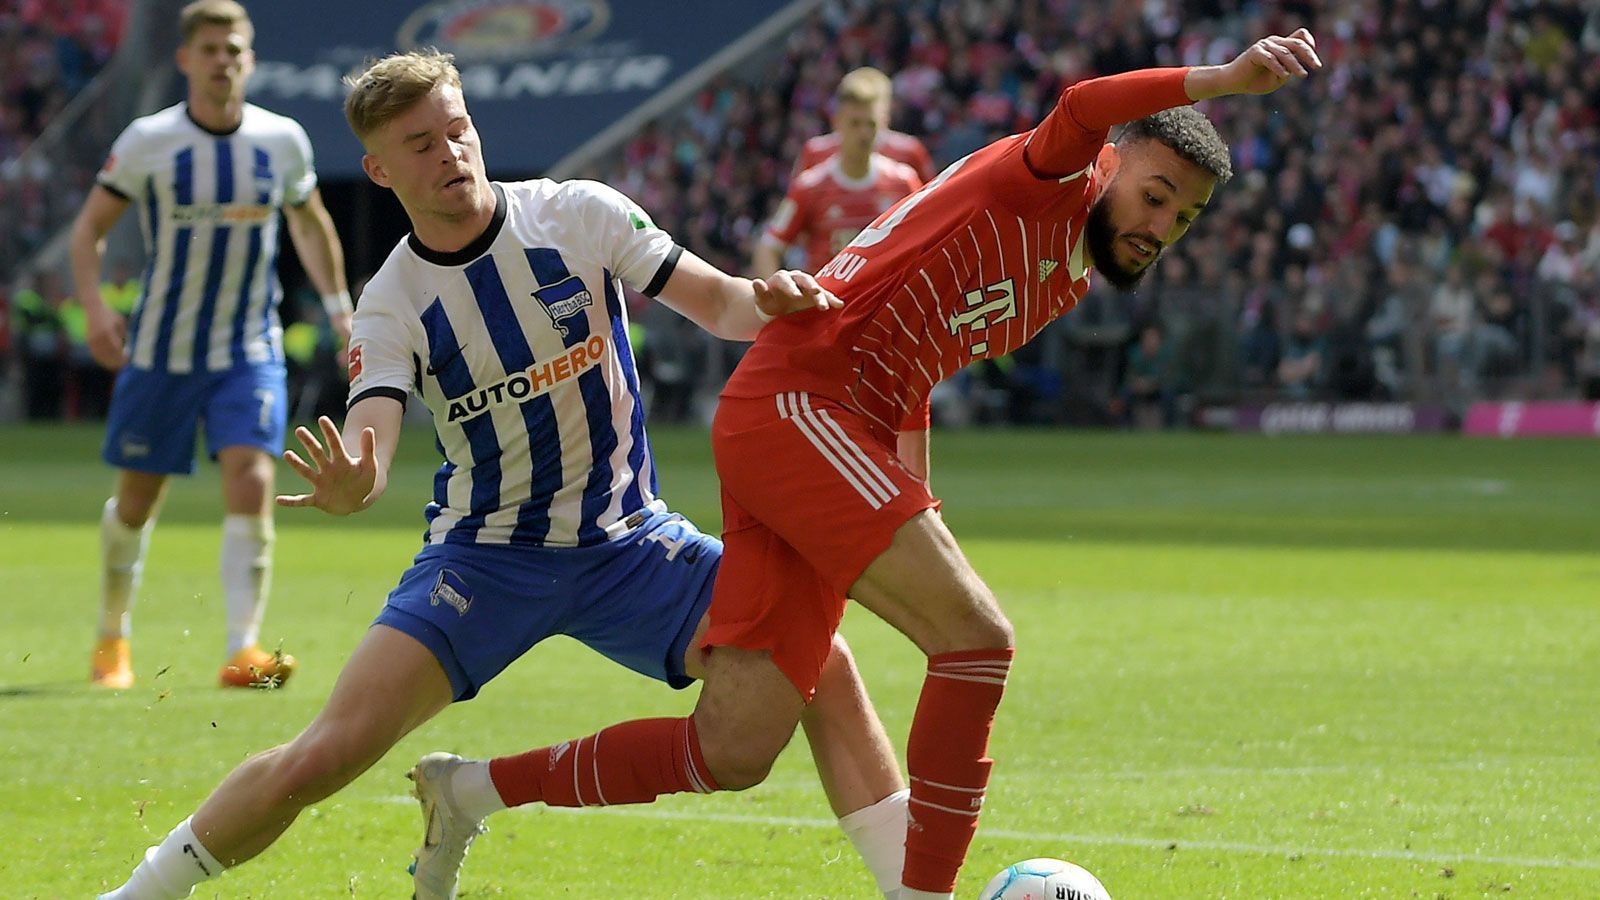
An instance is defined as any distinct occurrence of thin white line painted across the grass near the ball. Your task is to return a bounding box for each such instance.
[384,794,1600,870]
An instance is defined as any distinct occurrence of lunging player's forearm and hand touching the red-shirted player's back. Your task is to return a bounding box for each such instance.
[659,251,843,341]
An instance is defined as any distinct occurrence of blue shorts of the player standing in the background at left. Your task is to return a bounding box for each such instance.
[101,364,288,476]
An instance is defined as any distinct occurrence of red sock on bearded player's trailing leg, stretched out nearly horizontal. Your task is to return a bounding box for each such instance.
[490,719,717,806]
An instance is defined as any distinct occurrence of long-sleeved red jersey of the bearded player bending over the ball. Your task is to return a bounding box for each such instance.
[723,69,1192,442]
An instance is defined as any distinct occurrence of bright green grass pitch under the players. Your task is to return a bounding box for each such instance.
[0,426,1600,900]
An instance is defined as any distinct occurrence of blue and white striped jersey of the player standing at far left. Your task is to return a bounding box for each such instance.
[98,102,317,373]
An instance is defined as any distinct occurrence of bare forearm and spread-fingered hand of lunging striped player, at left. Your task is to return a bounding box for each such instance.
[278,396,405,516]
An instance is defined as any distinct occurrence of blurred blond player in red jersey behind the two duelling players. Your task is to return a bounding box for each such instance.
[750,69,926,275]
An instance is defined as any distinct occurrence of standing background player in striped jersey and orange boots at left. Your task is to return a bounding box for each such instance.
[72,0,350,689]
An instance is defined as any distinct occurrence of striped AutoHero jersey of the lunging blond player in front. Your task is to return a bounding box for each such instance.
[350,179,683,546]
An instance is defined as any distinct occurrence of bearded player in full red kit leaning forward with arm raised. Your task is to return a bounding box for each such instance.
[457,29,1322,900]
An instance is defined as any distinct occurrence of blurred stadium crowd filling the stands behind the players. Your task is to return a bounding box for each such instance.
[9,0,1600,424]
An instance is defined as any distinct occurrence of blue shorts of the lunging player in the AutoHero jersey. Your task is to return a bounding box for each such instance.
[374,512,722,700]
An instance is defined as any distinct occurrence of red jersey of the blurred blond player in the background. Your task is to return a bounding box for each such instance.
[763,154,922,272]
